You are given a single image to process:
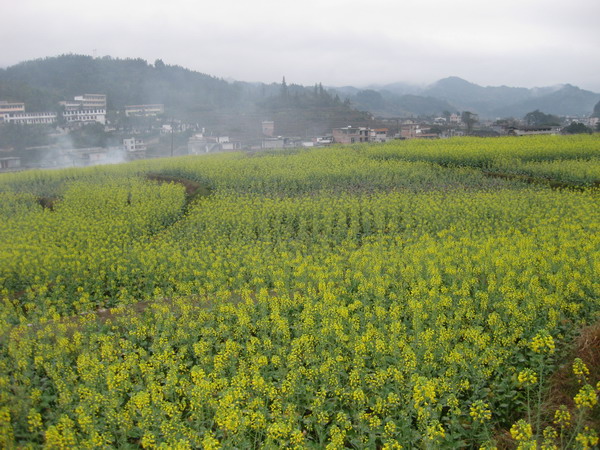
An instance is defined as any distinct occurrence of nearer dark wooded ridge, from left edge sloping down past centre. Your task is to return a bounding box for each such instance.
[0,55,370,135]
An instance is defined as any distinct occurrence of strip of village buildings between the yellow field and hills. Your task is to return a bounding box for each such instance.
[0,90,600,171]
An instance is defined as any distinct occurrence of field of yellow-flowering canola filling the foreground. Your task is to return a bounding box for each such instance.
[0,135,600,449]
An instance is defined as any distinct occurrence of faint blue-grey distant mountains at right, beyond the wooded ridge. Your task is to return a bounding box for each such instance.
[333,77,600,119]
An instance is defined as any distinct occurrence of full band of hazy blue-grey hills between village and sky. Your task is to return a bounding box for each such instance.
[0,55,600,128]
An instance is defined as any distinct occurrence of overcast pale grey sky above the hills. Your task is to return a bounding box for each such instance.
[0,0,600,92]
